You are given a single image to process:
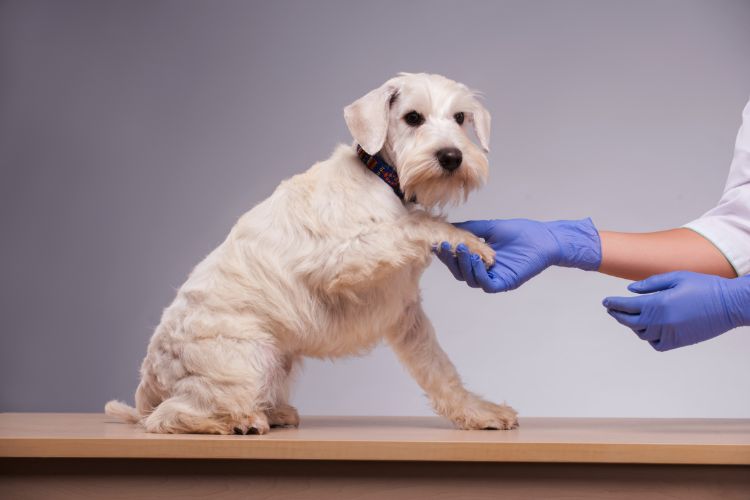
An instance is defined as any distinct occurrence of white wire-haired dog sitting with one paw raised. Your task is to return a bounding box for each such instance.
[105,74,517,434]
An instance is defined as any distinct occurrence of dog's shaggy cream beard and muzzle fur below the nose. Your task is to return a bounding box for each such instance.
[398,148,489,209]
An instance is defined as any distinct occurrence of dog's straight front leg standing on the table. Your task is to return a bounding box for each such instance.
[388,304,518,429]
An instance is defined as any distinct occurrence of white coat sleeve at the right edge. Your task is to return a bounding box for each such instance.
[684,102,750,276]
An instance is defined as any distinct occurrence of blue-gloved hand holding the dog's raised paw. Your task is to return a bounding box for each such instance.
[435,219,602,293]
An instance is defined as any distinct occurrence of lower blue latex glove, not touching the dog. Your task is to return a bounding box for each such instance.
[603,271,750,351]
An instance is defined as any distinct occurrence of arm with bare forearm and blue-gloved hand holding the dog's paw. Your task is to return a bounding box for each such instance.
[436,219,736,293]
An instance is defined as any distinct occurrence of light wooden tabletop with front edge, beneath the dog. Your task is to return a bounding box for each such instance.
[0,413,750,465]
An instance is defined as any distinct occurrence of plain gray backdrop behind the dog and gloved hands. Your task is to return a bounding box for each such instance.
[0,0,750,417]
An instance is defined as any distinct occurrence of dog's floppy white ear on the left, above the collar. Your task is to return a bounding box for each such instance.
[344,78,398,155]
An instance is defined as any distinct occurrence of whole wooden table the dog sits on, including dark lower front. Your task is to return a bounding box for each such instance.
[0,413,750,500]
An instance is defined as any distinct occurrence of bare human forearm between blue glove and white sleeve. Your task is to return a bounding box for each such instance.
[599,228,737,280]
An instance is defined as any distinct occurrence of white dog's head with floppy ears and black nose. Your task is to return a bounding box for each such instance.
[344,73,490,207]
